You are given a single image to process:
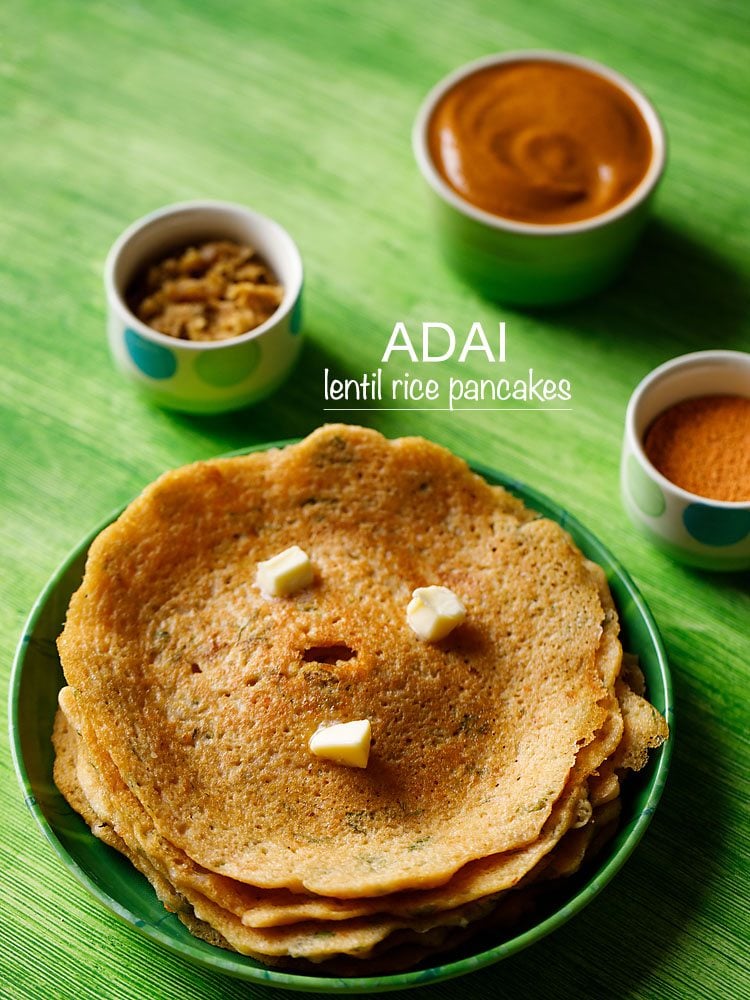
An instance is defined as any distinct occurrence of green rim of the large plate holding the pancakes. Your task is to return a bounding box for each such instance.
[8,452,674,994]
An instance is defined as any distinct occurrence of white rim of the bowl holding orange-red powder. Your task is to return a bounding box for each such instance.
[625,350,750,510]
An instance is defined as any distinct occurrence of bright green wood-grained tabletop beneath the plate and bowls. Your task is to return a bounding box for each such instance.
[0,0,750,1000]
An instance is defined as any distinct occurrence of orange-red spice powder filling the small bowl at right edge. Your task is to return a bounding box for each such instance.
[643,396,750,501]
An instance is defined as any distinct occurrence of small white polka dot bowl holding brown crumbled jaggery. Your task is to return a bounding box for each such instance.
[104,201,302,413]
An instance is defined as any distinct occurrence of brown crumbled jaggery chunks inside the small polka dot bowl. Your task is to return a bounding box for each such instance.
[128,240,284,340]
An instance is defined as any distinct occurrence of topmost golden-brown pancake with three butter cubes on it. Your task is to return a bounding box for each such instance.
[59,426,611,898]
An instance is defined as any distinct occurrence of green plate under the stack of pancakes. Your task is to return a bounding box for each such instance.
[10,450,673,993]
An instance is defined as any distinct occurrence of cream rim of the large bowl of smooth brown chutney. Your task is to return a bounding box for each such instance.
[412,49,667,237]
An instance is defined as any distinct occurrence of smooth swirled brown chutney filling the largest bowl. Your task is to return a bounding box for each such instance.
[428,58,653,225]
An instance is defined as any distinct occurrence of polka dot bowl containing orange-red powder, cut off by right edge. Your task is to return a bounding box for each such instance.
[621,351,750,570]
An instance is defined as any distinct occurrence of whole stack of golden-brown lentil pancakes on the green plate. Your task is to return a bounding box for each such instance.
[53,426,667,974]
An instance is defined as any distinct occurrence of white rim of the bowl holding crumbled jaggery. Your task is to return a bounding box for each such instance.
[103,198,304,351]
